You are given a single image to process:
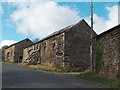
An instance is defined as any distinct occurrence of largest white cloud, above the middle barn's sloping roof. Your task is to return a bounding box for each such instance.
[11,1,80,38]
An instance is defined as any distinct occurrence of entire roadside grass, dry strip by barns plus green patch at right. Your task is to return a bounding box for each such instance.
[2,62,119,88]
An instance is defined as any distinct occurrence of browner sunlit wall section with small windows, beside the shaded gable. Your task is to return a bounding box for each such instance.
[41,33,64,66]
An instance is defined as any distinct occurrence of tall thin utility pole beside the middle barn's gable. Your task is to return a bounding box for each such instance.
[90,0,93,72]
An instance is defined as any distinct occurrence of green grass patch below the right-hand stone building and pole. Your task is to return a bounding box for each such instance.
[76,72,119,88]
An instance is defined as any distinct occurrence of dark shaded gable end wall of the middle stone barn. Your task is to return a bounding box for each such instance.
[65,21,96,70]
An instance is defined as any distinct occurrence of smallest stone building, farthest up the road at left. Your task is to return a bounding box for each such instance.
[4,38,32,63]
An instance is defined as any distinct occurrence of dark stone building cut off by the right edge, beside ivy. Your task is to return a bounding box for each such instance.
[96,25,120,77]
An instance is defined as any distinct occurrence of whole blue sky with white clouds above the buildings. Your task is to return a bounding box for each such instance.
[0,0,118,47]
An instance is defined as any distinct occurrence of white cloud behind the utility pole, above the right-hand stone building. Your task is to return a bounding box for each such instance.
[85,5,118,34]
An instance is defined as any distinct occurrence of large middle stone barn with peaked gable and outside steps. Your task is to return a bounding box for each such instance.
[23,20,96,70]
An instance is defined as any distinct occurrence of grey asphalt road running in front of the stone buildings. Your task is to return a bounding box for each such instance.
[2,64,99,88]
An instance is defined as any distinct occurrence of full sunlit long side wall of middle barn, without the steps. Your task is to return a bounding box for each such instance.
[23,33,64,66]
